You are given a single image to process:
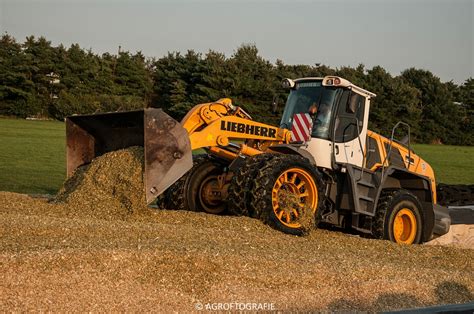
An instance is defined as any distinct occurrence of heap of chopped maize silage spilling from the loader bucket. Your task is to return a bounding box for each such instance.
[53,147,146,219]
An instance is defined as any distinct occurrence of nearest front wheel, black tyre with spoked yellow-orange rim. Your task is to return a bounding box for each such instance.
[250,155,325,235]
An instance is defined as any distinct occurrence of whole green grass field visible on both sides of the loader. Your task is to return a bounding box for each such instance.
[0,118,474,194]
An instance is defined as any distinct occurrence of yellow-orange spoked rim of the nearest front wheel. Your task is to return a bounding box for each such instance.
[272,168,318,228]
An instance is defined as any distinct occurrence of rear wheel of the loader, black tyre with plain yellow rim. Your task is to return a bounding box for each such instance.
[372,189,423,244]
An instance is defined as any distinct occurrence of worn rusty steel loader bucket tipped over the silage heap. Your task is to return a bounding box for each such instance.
[66,108,193,204]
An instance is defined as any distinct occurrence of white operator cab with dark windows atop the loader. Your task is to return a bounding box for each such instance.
[280,76,375,168]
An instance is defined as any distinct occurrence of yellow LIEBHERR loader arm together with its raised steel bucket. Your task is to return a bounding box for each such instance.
[66,98,291,203]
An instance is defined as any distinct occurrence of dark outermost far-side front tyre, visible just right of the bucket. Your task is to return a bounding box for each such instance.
[156,154,210,210]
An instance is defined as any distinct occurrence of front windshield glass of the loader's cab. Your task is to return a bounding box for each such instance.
[280,81,342,139]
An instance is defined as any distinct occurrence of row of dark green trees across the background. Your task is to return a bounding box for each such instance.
[0,34,474,145]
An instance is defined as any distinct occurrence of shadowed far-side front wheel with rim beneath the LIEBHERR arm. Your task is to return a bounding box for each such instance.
[184,160,227,214]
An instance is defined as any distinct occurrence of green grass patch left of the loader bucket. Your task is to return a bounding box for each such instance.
[0,118,66,194]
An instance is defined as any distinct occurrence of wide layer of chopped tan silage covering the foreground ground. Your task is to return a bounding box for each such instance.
[0,192,474,311]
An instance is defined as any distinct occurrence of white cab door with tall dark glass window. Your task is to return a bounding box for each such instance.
[334,90,369,168]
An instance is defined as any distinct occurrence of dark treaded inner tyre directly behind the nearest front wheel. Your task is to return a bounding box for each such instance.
[227,154,275,217]
